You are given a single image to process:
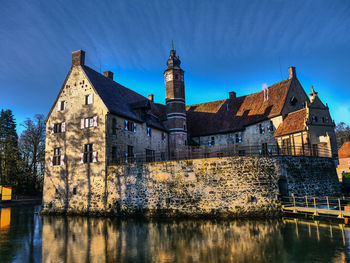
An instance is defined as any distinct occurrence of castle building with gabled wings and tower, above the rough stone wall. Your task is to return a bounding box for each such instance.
[44,50,337,216]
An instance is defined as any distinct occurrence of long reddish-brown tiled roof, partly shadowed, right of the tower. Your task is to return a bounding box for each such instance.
[186,79,292,136]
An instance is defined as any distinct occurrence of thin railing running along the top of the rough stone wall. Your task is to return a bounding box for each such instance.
[109,144,332,164]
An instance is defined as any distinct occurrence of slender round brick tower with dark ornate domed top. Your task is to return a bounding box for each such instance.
[164,48,187,157]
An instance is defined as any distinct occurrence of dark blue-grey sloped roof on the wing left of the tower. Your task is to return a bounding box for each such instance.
[82,66,166,130]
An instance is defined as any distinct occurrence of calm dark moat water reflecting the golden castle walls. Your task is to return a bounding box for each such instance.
[0,206,350,263]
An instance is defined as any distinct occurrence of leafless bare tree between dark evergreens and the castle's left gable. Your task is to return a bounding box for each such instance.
[19,114,46,193]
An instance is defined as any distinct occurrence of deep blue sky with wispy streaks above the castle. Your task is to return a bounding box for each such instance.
[0,0,350,133]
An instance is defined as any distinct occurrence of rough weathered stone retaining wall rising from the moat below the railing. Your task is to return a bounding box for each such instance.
[44,157,340,217]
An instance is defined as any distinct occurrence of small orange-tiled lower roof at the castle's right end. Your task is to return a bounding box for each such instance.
[274,109,307,137]
